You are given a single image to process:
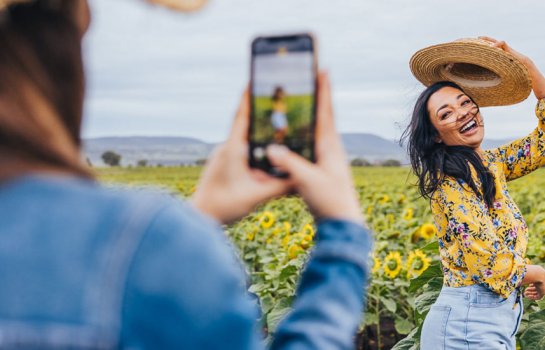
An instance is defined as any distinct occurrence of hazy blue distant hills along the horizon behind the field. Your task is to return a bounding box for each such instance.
[83,133,511,166]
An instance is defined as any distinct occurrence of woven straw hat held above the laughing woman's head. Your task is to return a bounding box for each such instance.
[409,39,532,107]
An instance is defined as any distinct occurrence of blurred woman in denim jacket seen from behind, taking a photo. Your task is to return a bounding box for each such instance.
[0,0,371,349]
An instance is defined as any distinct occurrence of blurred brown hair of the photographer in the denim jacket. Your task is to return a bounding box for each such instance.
[0,0,92,181]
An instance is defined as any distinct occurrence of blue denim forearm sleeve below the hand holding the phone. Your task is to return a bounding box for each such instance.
[272,220,372,349]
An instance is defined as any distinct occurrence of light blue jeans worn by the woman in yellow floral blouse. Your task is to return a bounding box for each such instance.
[420,285,523,350]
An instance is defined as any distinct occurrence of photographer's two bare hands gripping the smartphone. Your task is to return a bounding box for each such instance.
[192,74,363,224]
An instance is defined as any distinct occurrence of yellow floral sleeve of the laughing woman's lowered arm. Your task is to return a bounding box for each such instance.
[432,178,526,297]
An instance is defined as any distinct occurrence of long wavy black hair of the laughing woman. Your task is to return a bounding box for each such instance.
[401,81,496,207]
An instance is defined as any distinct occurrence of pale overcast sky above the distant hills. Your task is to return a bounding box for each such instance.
[83,0,545,142]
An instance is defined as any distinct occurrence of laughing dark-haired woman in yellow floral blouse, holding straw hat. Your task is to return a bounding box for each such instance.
[404,37,545,350]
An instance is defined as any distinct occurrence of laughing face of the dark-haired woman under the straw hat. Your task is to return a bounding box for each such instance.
[427,86,484,149]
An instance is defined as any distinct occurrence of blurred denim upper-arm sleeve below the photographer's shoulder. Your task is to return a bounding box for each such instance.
[122,203,262,349]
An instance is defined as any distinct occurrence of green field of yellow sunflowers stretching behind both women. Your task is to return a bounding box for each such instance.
[98,167,545,350]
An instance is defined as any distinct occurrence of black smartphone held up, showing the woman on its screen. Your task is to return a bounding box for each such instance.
[248,34,318,177]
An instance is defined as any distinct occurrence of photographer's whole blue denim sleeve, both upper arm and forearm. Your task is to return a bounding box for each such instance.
[122,198,371,350]
